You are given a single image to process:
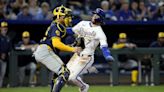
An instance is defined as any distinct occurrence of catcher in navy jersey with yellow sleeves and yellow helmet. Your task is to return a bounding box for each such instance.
[34,6,81,92]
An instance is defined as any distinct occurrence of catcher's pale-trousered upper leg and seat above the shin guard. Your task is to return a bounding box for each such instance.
[34,45,63,74]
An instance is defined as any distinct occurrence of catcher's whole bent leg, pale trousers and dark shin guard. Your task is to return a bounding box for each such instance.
[34,45,69,92]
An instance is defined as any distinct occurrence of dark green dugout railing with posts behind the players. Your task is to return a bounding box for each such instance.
[9,48,164,87]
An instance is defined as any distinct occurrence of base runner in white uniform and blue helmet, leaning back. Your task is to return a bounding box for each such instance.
[63,8,114,92]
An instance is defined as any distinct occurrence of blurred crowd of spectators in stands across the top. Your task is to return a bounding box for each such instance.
[0,0,164,21]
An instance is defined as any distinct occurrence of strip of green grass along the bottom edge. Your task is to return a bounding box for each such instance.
[0,85,164,92]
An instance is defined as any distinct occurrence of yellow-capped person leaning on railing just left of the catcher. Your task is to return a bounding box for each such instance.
[16,31,37,86]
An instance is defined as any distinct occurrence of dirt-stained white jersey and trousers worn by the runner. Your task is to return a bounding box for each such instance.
[67,21,108,87]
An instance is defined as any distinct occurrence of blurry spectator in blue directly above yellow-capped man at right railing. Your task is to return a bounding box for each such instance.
[118,2,133,21]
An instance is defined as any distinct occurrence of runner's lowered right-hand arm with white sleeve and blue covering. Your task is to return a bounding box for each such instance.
[99,31,114,61]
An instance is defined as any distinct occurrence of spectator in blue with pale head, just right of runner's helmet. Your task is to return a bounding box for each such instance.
[101,1,117,21]
